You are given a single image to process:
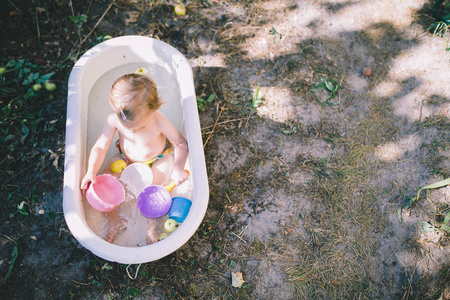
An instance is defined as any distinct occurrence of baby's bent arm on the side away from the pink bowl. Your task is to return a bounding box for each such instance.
[158,114,189,184]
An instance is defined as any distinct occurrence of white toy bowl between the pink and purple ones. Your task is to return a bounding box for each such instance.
[120,163,153,195]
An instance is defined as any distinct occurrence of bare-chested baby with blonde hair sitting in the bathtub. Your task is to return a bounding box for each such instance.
[80,73,188,242]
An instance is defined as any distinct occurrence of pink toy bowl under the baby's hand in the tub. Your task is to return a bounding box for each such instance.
[86,174,125,212]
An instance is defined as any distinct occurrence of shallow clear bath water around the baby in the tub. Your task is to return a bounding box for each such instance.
[83,63,192,247]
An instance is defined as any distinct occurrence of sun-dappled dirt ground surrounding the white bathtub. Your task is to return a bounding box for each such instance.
[0,0,450,299]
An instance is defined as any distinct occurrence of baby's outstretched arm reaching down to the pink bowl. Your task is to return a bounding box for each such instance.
[80,113,117,190]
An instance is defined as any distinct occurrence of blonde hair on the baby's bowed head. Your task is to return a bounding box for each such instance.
[109,73,163,121]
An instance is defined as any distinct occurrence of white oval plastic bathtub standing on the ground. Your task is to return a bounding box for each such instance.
[63,36,209,264]
